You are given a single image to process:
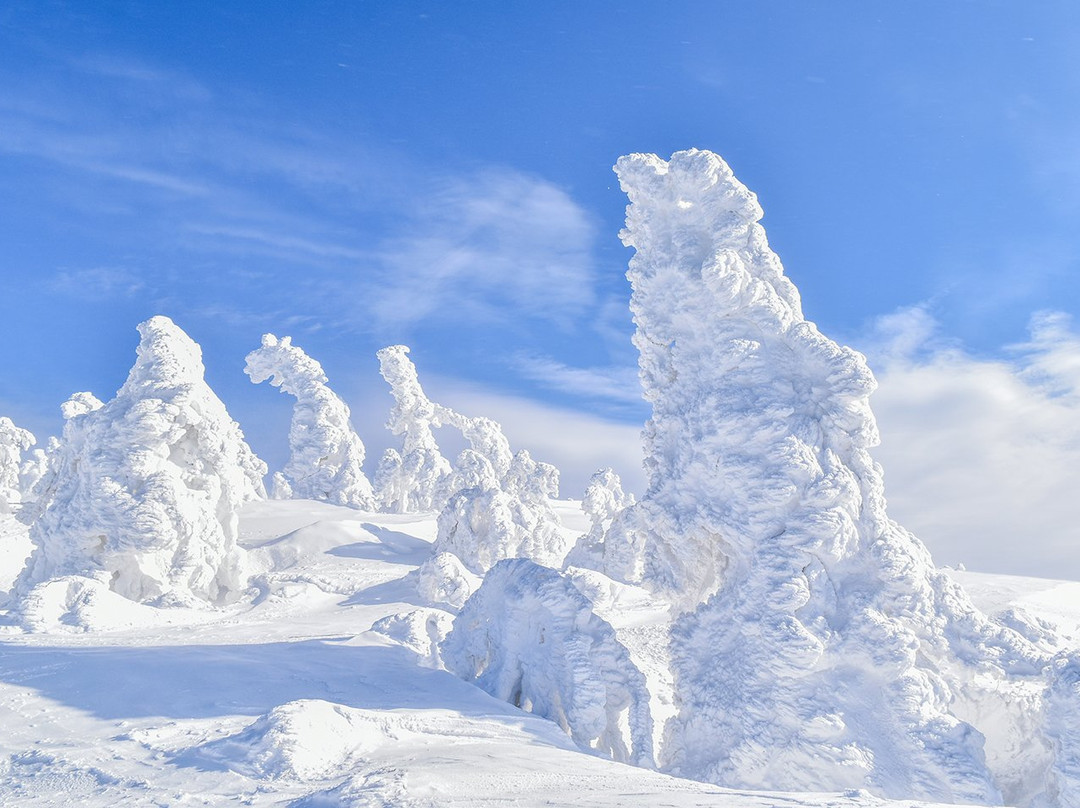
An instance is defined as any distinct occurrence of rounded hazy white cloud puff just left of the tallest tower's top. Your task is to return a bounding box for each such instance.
[373,170,594,323]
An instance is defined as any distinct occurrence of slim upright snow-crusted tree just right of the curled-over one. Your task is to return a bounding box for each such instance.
[375,345,450,513]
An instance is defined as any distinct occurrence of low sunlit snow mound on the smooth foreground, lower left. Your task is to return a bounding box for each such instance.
[195,699,393,781]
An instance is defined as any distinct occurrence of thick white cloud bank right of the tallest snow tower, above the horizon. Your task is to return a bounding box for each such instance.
[868,307,1080,578]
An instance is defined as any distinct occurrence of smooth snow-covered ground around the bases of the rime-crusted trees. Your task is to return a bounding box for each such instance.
[0,500,1002,808]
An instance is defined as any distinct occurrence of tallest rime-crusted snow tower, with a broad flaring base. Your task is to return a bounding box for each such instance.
[605,150,1048,803]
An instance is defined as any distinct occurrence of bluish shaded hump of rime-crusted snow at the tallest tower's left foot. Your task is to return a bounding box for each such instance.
[442,558,652,766]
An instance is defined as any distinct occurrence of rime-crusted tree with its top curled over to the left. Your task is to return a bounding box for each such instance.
[244,334,375,510]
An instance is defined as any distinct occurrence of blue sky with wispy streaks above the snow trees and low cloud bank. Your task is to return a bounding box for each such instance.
[0,0,1080,578]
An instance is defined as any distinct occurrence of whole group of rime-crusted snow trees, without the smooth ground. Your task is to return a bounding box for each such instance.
[0,150,1080,808]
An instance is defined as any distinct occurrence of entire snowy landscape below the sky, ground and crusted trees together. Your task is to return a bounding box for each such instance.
[0,151,1080,808]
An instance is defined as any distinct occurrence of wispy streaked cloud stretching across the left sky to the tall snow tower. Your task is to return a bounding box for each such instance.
[0,56,609,338]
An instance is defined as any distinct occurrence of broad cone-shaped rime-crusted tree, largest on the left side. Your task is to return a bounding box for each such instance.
[16,317,266,603]
